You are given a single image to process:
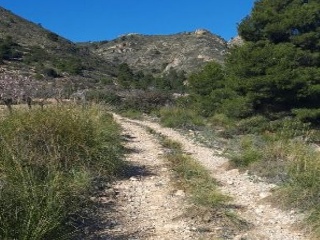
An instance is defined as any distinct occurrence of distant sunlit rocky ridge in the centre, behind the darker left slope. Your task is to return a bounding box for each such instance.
[81,29,227,73]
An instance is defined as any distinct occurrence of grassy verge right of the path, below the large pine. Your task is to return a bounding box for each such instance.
[218,119,320,238]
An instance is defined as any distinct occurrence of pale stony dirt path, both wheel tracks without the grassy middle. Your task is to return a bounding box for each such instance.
[94,115,307,240]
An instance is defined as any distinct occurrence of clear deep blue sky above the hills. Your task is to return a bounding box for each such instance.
[0,0,254,42]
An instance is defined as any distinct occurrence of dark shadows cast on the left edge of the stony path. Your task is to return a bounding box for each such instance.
[72,132,155,240]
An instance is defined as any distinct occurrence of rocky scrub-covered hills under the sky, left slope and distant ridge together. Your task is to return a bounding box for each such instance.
[0,7,234,97]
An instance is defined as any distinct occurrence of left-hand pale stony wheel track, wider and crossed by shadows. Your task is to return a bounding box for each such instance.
[94,116,198,240]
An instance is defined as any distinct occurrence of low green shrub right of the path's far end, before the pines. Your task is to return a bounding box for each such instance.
[160,107,204,128]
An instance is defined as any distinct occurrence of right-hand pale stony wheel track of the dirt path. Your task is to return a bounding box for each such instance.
[115,115,308,240]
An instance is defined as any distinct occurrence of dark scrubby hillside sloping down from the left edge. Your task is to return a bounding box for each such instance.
[0,7,117,94]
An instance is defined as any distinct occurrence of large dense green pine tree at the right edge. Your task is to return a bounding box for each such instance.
[226,0,320,121]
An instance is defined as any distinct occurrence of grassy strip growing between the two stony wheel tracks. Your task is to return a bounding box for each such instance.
[148,128,249,236]
